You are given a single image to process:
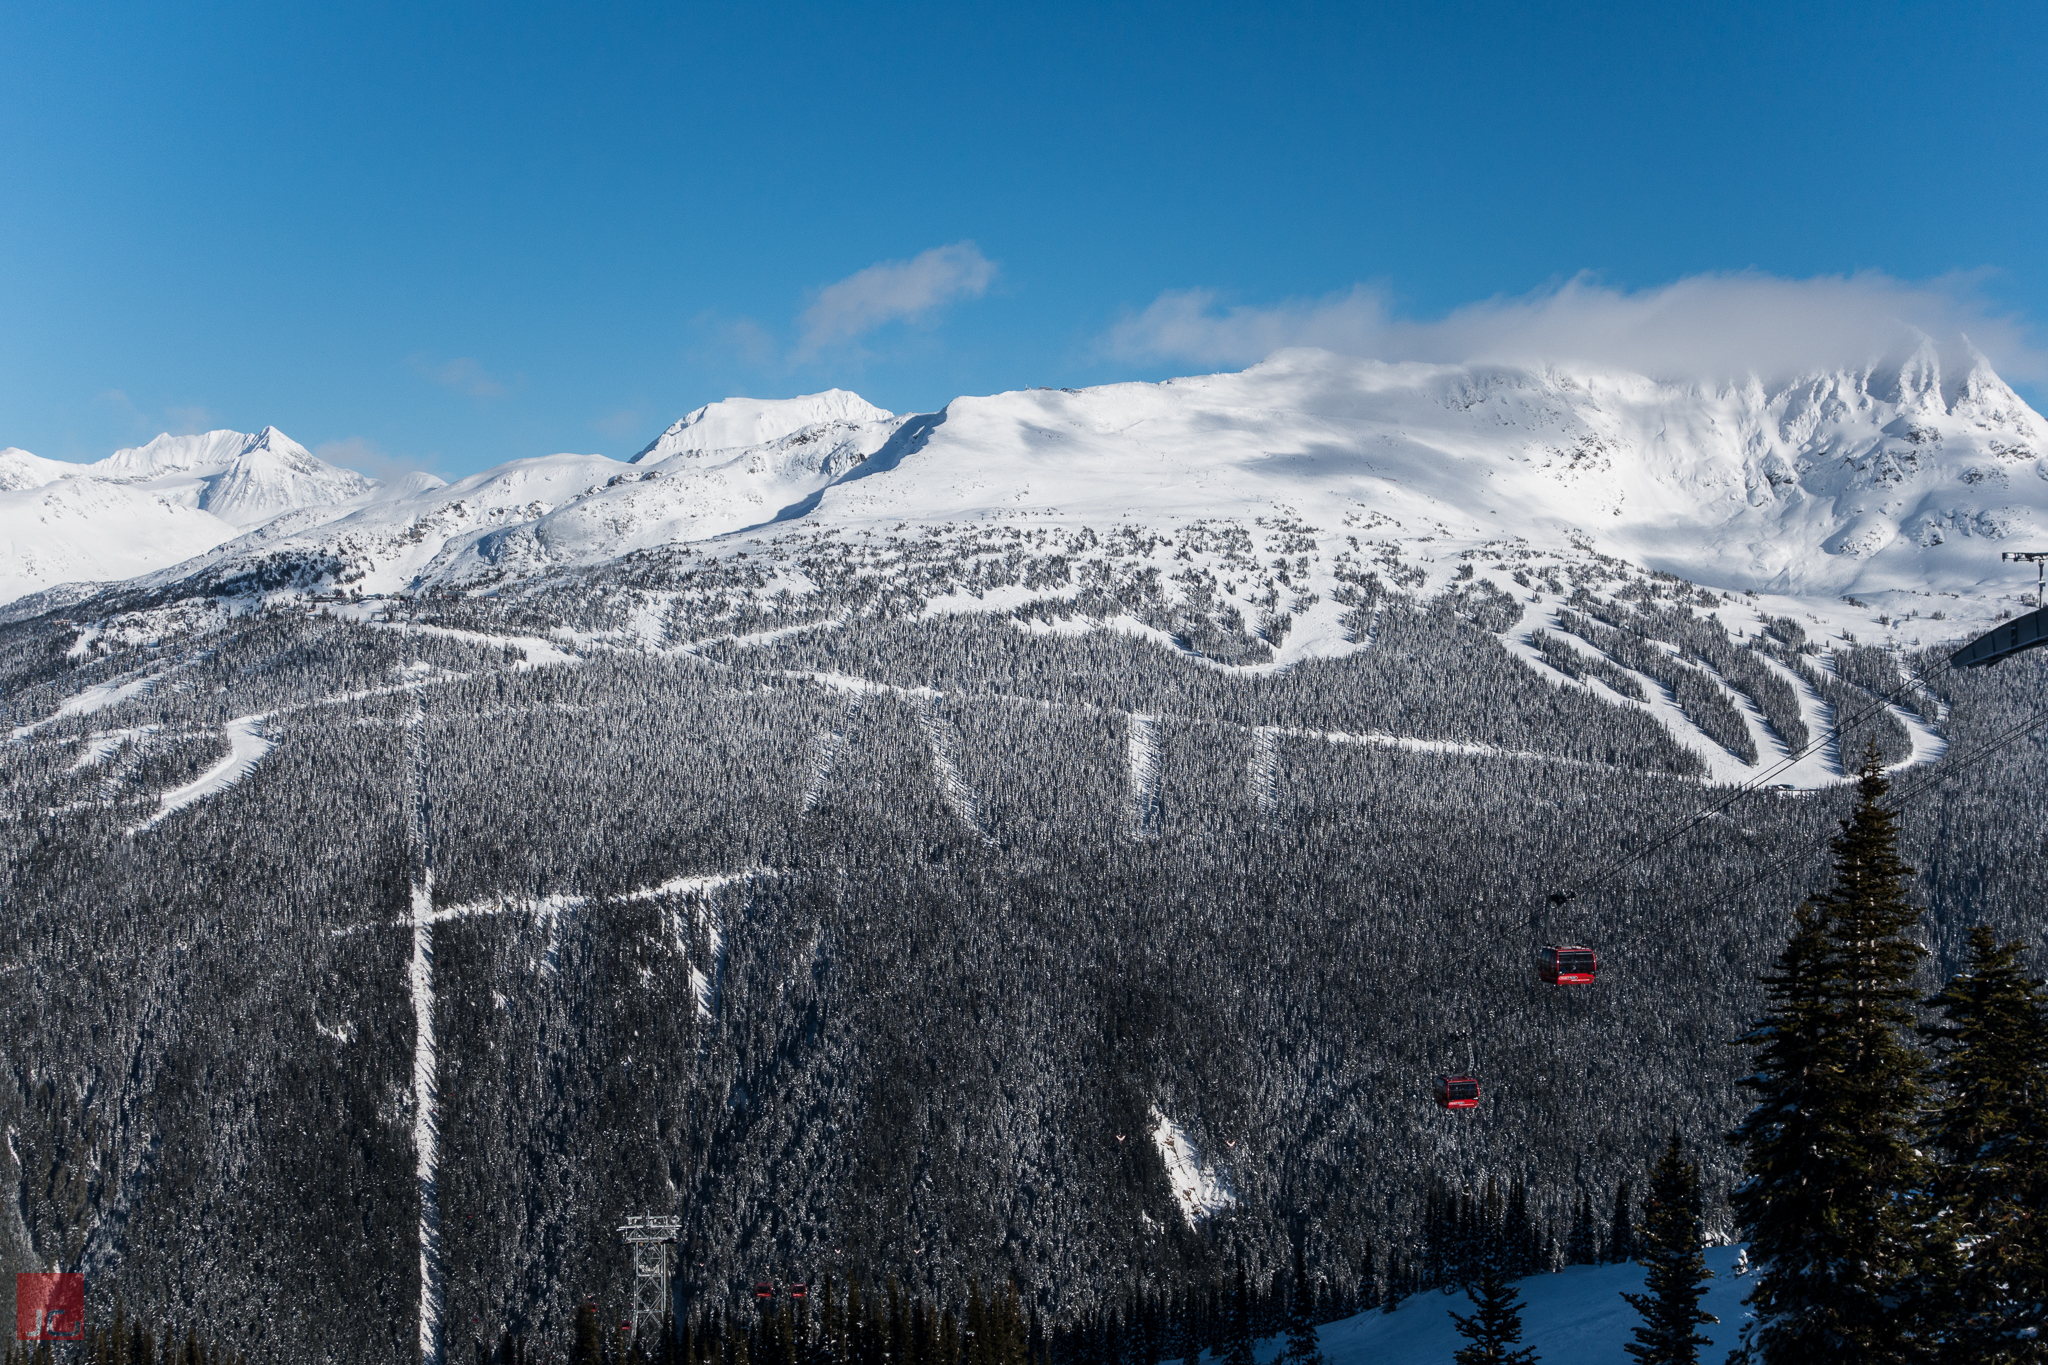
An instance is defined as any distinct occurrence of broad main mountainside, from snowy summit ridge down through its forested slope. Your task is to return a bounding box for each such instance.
[0,352,2048,1365]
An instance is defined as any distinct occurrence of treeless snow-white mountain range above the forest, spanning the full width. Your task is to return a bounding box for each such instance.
[0,342,2048,634]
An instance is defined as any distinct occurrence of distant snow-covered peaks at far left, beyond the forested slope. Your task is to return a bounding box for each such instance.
[0,426,428,600]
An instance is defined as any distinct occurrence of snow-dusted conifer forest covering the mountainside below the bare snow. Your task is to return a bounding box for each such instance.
[0,536,2048,1365]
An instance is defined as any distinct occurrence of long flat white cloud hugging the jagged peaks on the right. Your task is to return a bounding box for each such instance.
[1102,272,2048,379]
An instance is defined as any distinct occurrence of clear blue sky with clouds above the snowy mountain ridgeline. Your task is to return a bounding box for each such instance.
[0,2,2048,475]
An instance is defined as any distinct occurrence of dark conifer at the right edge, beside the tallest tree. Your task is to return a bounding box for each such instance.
[1919,925,2048,1361]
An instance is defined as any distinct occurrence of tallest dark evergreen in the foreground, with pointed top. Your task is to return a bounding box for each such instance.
[1731,753,1927,1365]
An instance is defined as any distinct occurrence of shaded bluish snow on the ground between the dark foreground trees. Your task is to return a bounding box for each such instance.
[1257,1246,1755,1365]
